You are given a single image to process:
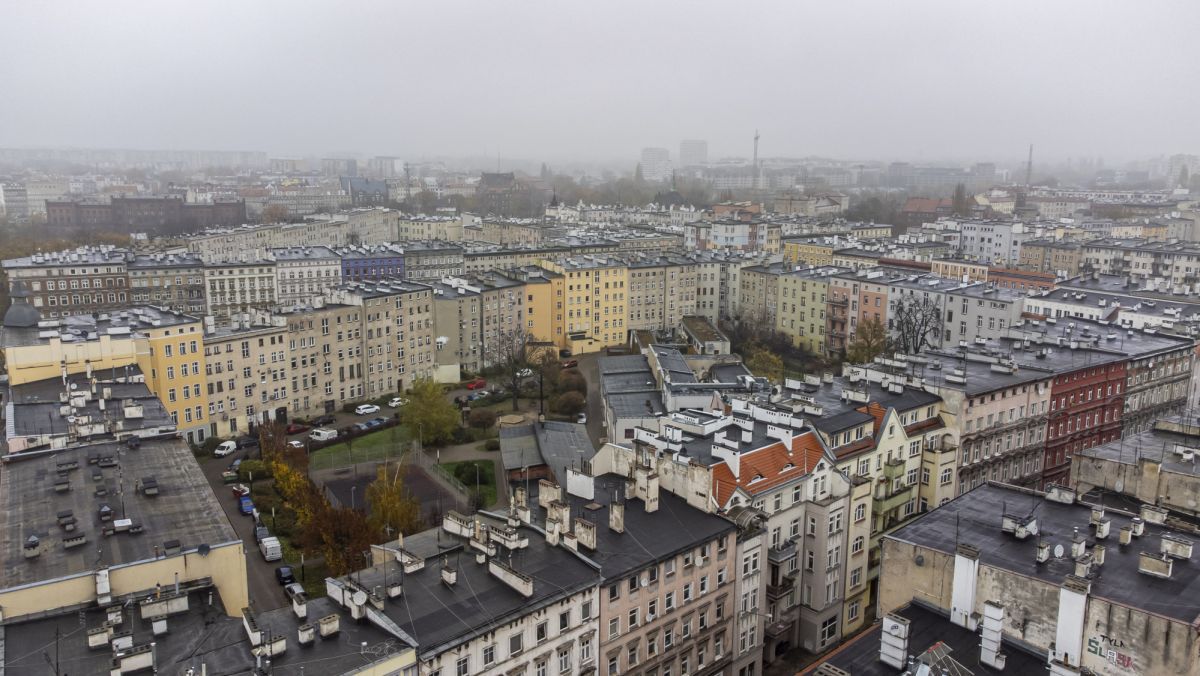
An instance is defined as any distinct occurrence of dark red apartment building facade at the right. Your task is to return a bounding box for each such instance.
[1042,355,1128,487]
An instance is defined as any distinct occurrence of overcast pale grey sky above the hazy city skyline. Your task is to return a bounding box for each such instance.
[0,0,1200,161]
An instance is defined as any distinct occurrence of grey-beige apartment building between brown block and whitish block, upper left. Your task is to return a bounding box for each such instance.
[127,252,206,315]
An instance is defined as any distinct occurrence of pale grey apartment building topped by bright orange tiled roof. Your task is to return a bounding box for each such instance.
[596,397,865,662]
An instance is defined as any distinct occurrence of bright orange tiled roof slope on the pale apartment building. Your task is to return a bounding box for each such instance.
[713,431,824,507]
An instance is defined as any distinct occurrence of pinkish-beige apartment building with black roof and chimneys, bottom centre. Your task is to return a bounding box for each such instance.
[530,466,737,675]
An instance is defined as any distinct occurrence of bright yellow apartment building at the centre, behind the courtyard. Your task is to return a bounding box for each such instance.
[540,256,629,354]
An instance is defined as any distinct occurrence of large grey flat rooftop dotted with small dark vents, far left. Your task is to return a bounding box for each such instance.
[0,438,240,587]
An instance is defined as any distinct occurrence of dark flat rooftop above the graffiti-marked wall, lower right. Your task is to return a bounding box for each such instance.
[884,483,1200,622]
